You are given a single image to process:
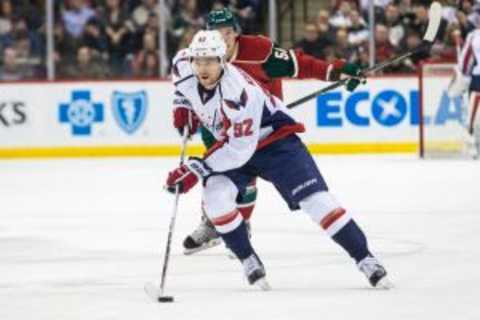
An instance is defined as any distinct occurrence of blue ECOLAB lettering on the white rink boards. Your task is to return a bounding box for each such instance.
[317,88,462,128]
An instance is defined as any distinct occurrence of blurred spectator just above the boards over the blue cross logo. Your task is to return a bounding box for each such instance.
[61,46,109,79]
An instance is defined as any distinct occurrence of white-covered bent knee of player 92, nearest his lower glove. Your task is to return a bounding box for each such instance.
[202,175,238,220]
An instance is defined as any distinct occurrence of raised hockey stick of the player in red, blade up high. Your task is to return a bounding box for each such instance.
[287,2,442,109]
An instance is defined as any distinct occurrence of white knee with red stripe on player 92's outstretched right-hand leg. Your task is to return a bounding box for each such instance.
[300,191,351,236]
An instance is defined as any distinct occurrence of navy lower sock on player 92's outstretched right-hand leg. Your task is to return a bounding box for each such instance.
[332,220,371,263]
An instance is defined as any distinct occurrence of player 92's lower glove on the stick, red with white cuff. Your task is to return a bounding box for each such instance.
[166,157,212,193]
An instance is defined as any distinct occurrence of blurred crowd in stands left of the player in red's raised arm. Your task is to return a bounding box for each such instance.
[0,0,265,81]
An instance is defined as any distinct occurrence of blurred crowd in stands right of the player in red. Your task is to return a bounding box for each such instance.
[295,0,474,73]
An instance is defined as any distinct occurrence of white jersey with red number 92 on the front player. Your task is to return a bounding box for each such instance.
[172,50,304,172]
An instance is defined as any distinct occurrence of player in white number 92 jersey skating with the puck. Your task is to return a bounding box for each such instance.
[166,31,391,290]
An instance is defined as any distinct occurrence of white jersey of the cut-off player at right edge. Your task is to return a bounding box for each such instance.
[457,29,480,76]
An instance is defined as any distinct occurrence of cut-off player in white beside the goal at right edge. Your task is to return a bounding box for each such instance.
[448,29,480,158]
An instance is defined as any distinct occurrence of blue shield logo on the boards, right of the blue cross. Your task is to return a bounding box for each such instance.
[112,91,148,134]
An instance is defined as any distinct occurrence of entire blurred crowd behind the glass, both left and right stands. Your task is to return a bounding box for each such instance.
[0,0,480,81]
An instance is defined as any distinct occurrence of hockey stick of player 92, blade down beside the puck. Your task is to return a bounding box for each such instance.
[145,128,189,302]
